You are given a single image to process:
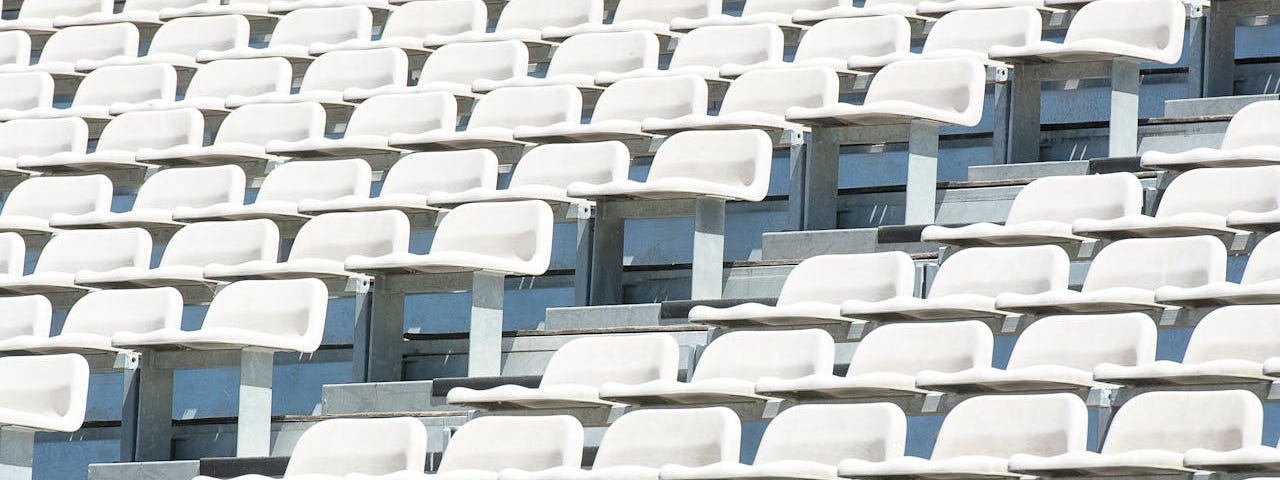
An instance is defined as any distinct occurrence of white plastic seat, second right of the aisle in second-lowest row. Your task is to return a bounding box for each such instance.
[600,329,835,406]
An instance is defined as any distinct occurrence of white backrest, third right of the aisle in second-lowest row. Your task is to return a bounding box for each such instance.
[849,320,995,376]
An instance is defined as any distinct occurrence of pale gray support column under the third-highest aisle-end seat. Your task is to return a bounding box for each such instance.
[690,197,724,300]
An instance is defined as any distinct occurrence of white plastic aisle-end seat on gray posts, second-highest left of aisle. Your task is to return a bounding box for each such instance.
[786,58,987,127]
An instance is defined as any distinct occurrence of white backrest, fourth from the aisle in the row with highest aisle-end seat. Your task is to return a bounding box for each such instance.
[669,24,782,69]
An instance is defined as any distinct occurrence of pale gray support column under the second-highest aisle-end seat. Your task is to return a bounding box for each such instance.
[904,120,938,225]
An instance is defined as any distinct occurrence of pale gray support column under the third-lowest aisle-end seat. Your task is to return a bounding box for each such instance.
[467,271,506,376]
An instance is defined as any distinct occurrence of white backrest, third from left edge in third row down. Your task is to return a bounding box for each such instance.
[186,56,293,99]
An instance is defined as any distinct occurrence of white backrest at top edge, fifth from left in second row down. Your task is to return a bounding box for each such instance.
[383,0,489,38]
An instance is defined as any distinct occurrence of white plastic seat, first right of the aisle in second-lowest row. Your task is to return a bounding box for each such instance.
[448,333,680,411]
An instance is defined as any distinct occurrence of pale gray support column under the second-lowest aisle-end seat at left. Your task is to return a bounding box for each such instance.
[236,347,275,457]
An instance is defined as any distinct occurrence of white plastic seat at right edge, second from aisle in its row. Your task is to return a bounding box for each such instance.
[1073,165,1280,238]
